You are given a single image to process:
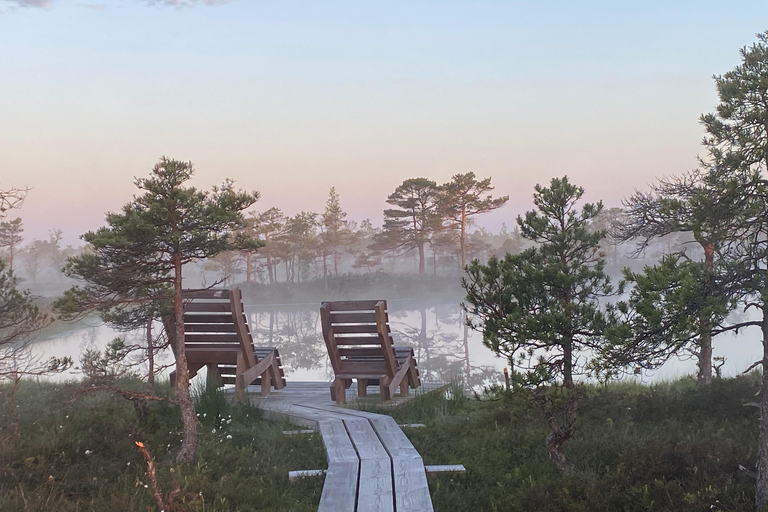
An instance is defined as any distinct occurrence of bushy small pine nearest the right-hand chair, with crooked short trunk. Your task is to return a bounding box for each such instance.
[462,177,612,474]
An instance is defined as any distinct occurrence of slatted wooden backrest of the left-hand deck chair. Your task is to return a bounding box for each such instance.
[178,288,256,368]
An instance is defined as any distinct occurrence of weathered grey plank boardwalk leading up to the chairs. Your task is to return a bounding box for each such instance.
[249,382,433,512]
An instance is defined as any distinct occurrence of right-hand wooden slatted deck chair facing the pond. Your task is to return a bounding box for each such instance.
[320,300,421,404]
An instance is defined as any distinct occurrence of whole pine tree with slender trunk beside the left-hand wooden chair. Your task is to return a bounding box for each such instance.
[54,157,258,463]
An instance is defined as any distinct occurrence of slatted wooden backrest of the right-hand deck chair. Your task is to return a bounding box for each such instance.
[320,300,398,377]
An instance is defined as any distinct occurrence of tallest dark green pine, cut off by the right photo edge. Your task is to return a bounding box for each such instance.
[701,32,768,510]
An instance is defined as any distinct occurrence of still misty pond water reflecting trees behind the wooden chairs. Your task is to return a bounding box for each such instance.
[35,299,761,389]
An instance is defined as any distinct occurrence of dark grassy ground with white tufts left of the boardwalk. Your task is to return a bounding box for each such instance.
[0,382,325,512]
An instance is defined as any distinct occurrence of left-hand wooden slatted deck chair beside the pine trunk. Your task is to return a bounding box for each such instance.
[165,288,285,398]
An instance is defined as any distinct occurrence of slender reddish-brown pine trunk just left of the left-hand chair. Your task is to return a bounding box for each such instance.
[173,254,197,464]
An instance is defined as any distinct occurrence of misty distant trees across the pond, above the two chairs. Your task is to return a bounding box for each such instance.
[237,172,509,284]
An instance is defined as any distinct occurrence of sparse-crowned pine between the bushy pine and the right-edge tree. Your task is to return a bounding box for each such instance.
[612,170,748,386]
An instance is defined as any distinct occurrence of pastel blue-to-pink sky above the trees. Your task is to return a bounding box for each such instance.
[0,0,768,244]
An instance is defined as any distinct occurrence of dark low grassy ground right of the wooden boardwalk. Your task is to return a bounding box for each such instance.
[393,376,759,512]
